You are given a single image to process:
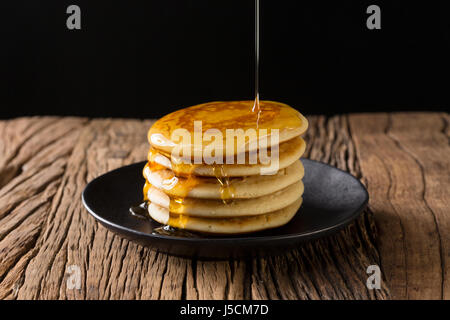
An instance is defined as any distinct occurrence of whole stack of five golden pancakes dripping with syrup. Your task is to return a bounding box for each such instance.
[143,101,308,234]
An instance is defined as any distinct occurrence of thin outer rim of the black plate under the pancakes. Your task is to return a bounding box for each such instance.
[81,158,369,244]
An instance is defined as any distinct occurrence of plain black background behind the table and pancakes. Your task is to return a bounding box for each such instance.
[0,0,450,118]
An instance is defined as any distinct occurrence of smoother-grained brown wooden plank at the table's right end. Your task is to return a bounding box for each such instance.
[350,113,450,299]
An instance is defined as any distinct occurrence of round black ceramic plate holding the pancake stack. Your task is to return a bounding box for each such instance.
[82,159,369,258]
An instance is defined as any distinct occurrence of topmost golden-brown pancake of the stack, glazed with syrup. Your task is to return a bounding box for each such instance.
[148,101,308,156]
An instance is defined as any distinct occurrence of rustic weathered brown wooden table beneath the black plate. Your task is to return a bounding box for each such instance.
[0,113,450,299]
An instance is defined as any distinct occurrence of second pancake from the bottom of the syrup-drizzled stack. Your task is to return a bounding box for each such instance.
[148,181,304,218]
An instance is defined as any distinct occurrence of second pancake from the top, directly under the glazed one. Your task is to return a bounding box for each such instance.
[148,137,306,177]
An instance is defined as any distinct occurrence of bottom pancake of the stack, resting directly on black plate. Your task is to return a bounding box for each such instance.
[148,197,302,234]
